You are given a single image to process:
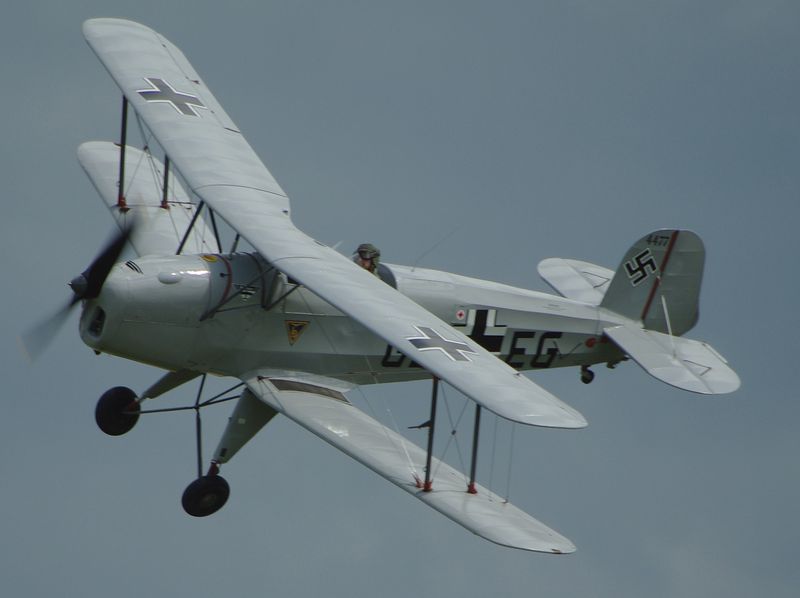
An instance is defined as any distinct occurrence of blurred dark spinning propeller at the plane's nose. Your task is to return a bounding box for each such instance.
[20,226,133,361]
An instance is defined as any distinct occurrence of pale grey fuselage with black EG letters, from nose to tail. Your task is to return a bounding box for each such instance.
[80,253,623,384]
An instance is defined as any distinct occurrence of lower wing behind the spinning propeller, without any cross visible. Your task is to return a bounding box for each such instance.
[78,141,219,255]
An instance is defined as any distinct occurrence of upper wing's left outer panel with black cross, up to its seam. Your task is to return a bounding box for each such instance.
[83,19,289,210]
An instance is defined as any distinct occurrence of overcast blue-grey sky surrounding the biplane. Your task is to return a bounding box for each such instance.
[0,0,800,598]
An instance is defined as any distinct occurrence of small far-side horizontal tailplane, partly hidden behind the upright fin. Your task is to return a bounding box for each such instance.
[537,257,614,305]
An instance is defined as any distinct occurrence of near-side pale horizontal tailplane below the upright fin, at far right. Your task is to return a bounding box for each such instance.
[604,326,741,394]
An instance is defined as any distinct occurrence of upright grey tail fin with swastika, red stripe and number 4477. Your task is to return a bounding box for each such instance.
[600,229,705,336]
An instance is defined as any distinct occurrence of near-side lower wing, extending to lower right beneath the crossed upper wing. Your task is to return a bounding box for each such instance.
[244,374,575,554]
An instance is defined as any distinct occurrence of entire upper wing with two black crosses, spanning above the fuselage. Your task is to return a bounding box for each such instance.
[84,19,586,428]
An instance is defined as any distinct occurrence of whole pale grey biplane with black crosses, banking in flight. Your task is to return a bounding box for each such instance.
[23,19,739,553]
